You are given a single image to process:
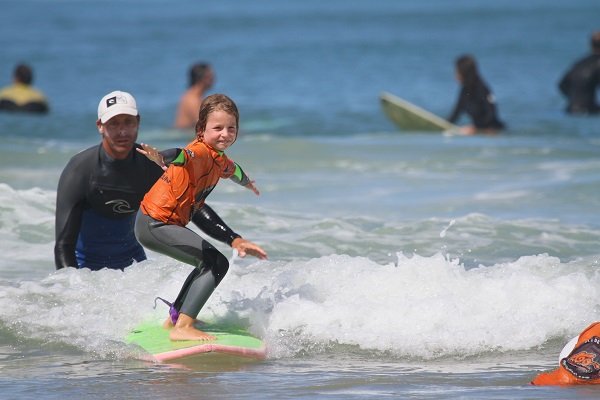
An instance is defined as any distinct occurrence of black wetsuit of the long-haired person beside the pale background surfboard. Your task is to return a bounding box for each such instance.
[448,82,504,130]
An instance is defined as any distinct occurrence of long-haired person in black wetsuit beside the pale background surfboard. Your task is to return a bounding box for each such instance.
[448,55,504,135]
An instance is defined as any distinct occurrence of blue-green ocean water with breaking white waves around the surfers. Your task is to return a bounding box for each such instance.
[0,0,600,399]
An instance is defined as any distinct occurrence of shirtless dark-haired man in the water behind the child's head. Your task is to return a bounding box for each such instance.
[174,63,215,129]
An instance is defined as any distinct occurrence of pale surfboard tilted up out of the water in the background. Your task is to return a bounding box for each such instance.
[379,92,460,133]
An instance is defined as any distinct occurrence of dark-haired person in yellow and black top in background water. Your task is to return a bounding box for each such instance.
[0,64,49,114]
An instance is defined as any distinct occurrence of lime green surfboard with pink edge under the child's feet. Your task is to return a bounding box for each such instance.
[126,322,266,362]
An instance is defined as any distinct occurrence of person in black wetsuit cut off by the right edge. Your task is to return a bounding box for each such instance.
[558,31,600,114]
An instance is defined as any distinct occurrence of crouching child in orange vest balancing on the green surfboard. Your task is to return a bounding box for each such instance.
[135,94,267,340]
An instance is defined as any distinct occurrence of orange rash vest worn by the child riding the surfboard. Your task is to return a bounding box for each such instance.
[140,140,239,226]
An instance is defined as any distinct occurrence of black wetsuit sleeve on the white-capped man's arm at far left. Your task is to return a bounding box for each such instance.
[54,156,87,269]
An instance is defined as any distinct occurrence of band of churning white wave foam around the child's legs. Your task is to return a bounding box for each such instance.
[0,250,600,359]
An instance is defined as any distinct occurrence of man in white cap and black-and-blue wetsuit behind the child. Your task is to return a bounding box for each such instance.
[54,91,258,270]
